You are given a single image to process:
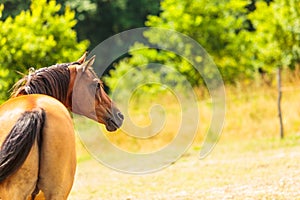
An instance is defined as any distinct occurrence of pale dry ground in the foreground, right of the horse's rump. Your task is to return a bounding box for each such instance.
[69,140,300,200]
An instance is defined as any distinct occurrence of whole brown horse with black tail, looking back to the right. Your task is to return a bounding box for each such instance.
[0,54,123,200]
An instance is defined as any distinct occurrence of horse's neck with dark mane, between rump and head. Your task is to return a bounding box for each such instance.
[12,62,79,102]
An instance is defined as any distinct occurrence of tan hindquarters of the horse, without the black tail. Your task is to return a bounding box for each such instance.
[0,94,76,200]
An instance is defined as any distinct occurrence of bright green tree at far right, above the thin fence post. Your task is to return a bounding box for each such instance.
[249,0,300,71]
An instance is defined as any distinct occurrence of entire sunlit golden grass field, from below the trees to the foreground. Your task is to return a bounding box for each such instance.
[69,75,300,200]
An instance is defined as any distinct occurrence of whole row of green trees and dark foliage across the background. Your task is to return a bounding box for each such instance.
[0,0,300,99]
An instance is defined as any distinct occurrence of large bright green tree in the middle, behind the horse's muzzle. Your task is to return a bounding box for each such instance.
[107,0,251,93]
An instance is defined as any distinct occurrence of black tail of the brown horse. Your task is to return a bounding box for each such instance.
[0,109,46,182]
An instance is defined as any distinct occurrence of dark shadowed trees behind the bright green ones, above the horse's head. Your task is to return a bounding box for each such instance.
[0,0,161,49]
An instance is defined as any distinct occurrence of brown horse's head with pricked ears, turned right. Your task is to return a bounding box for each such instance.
[67,54,124,131]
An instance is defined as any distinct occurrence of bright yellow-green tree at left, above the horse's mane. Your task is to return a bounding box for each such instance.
[0,0,89,100]
